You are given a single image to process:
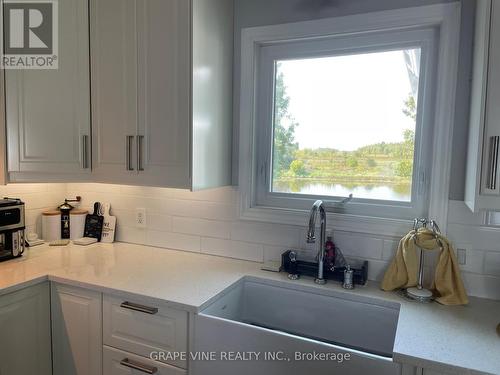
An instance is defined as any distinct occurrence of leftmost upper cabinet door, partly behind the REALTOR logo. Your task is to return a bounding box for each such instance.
[5,0,90,181]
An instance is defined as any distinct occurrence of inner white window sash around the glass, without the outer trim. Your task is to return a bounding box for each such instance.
[255,27,437,218]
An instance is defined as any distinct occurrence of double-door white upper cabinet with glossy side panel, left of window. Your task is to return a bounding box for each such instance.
[91,0,233,189]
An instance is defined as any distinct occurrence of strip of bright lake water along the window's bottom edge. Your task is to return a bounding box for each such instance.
[273,179,411,202]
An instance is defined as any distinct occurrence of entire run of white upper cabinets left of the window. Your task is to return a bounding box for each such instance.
[0,0,233,190]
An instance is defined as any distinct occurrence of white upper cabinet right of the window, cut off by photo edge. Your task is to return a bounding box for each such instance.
[465,0,500,212]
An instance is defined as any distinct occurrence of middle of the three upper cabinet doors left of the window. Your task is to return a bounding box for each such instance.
[91,0,137,183]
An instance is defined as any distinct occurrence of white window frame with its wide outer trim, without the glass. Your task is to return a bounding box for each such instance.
[239,3,460,236]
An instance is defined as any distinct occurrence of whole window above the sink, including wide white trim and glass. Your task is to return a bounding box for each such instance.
[239,4,459,232]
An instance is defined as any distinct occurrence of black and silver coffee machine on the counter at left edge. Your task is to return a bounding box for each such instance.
[0,198,26,262]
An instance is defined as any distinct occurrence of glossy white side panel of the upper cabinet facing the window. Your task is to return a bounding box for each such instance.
[191,0,233,190]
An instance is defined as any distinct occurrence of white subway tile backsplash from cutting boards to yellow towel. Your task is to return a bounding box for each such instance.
[66,184,397,274]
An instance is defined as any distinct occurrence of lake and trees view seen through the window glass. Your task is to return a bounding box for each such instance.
[271,48,420,202]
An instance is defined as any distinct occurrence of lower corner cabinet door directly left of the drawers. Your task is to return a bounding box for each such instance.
[51,284,102,375]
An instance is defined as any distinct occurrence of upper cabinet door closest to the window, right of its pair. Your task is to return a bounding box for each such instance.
[136,0,190,188]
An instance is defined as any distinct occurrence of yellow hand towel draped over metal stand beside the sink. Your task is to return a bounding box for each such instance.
[382,228,468,305]
